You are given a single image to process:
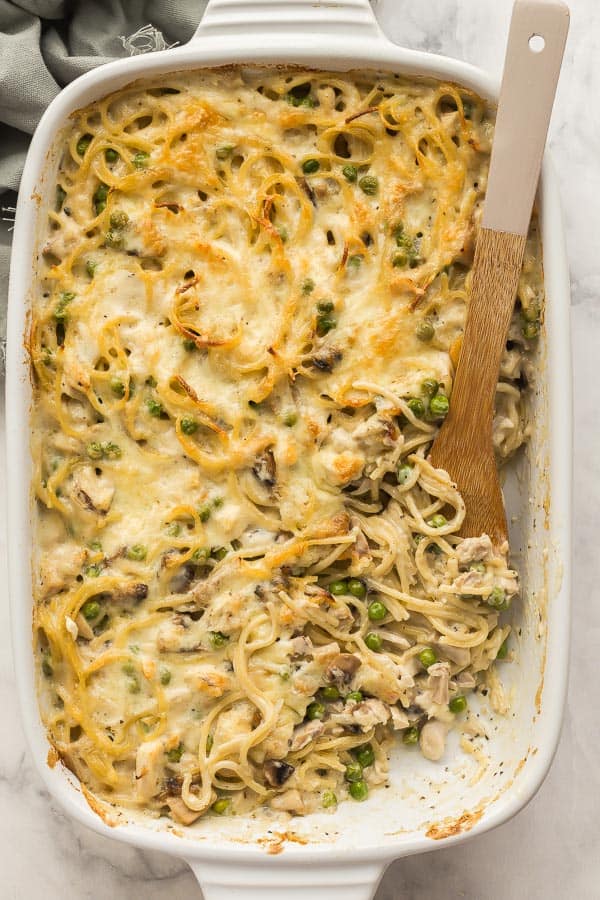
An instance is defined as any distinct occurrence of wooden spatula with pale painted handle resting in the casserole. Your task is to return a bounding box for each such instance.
[430,0,569,546]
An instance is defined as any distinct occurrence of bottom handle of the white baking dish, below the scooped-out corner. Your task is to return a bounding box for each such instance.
[188,857,387,900]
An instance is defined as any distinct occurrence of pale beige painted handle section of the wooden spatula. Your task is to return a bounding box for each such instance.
[483,0,569,234]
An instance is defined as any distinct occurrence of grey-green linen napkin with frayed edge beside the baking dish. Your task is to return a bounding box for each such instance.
[0,0,206,368]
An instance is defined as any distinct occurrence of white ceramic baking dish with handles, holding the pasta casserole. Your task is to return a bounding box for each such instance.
[7,0,571,900]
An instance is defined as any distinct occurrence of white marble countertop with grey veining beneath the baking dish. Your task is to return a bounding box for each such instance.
[0,0,600,900]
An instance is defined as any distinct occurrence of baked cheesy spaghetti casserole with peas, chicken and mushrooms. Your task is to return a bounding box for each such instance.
[30,70,542,824]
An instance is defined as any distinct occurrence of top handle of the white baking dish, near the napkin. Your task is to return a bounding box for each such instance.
[192,0,385,41]
